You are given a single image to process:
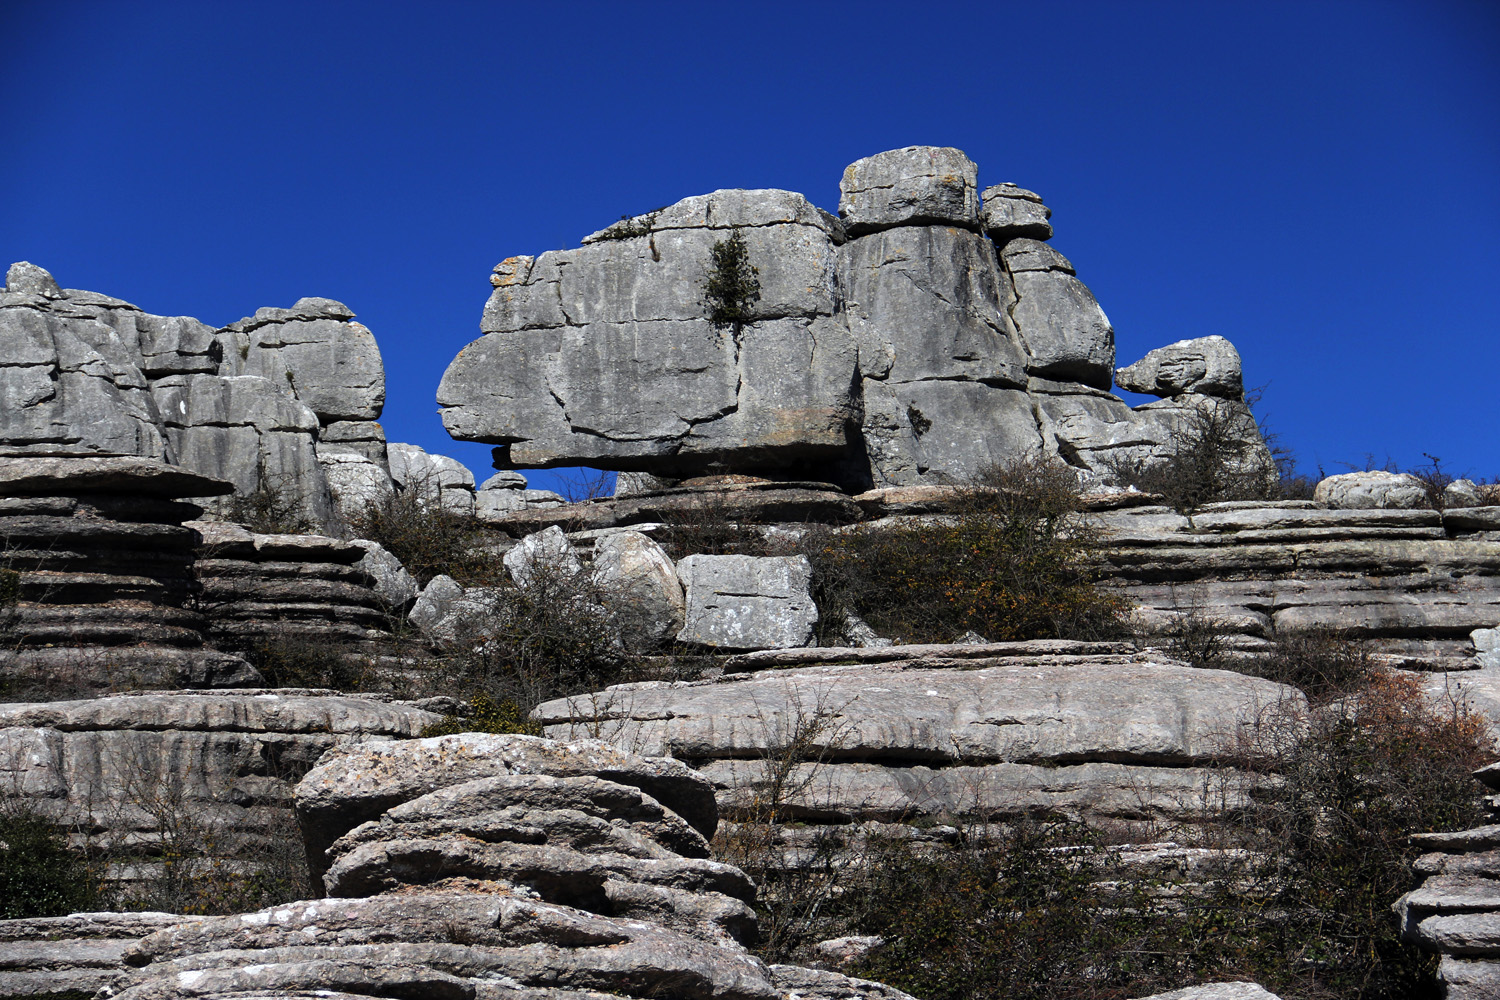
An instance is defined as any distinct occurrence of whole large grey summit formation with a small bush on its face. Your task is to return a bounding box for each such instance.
[438,147,1269,496]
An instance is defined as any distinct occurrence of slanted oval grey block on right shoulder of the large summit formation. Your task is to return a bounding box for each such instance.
[1001,240,1115,390]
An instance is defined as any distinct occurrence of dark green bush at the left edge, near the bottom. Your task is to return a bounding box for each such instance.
[0,805,98,921]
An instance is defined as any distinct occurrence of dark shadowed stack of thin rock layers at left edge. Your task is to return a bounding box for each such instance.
[0,457,260,697]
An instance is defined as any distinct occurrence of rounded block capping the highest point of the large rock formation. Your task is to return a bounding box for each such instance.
[839,145,980,235]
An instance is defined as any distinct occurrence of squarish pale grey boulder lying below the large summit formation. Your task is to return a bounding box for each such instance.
[677,555,818,649]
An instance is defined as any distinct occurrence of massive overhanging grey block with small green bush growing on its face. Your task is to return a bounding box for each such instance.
[438,190,855,474]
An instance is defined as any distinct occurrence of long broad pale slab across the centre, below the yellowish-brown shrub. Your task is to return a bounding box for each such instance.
[534,640,1301,823]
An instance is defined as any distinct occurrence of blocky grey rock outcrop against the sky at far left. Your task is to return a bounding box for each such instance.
[0,262,386,536]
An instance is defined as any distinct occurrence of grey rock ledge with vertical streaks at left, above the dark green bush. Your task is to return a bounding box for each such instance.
[0,690,443,858]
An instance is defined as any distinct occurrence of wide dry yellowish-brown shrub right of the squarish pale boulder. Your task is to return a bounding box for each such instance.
[803,459,1125,642]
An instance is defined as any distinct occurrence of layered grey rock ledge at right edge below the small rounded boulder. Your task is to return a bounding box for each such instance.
[1095,501,1500,670]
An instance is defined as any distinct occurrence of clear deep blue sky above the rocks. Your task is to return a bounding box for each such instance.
[0,0,1500,484]
